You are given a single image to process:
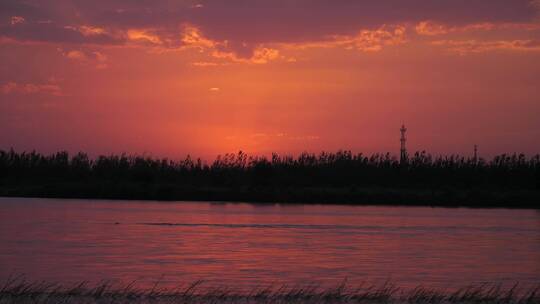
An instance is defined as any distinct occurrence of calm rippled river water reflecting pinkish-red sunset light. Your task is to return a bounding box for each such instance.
[0,198,540,288]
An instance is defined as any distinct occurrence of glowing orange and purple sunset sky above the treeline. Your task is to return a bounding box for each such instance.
[0,0,540,158]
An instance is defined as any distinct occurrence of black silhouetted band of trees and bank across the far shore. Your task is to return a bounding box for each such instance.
[0,150,540,208]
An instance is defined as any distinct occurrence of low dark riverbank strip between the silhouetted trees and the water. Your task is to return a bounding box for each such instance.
[0,182,540,209]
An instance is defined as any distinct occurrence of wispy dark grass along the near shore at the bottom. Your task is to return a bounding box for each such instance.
[0,279,540,304]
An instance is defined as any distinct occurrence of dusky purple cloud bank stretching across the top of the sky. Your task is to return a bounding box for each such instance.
[0,0,537,46]
